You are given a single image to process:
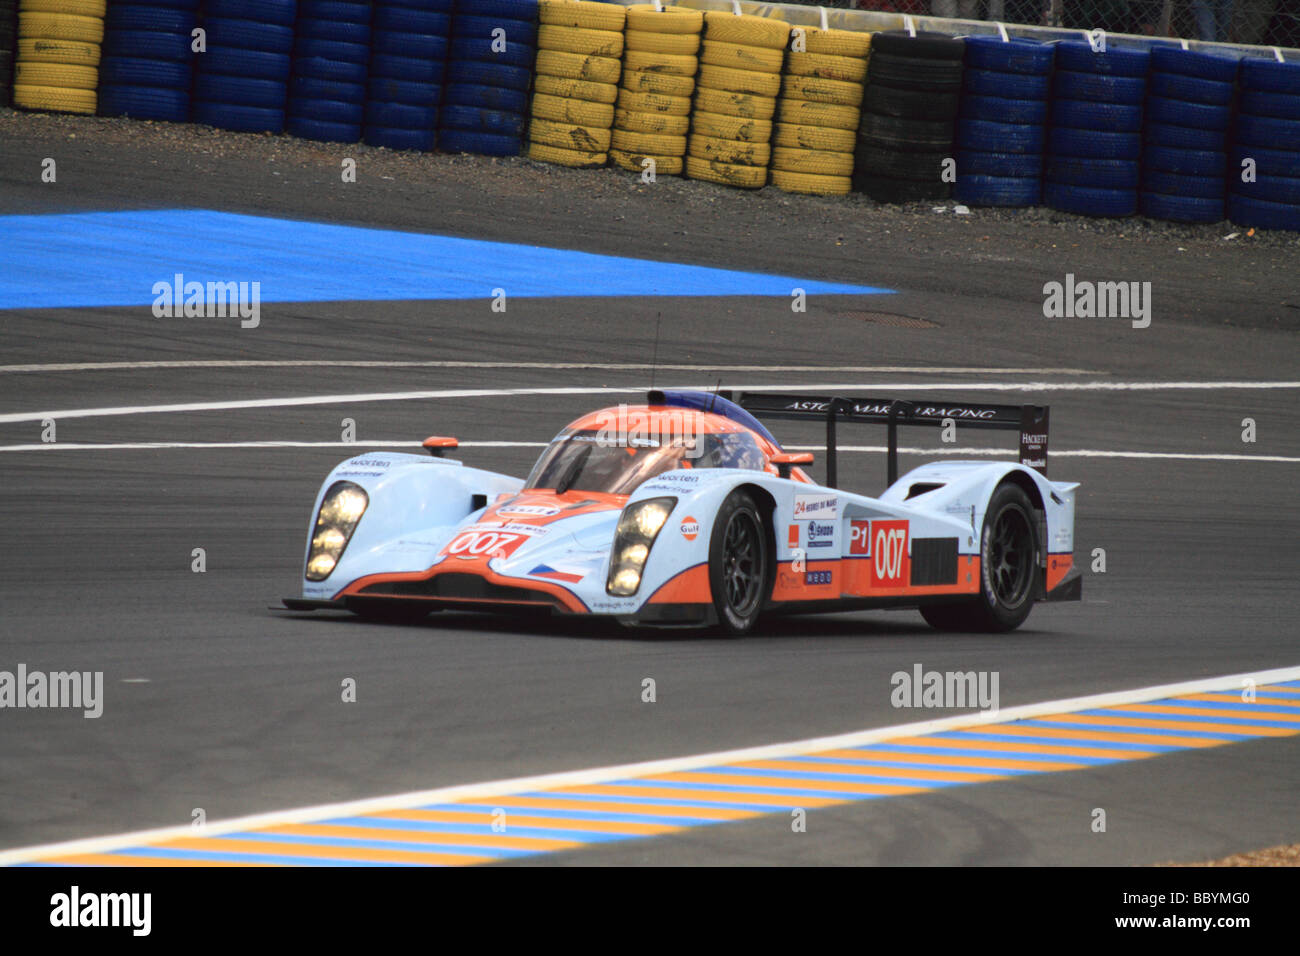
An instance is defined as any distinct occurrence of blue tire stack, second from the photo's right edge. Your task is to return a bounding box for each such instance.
[1140,47,1238,222]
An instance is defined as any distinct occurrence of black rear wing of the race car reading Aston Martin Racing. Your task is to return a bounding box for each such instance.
[724,392,1049,488]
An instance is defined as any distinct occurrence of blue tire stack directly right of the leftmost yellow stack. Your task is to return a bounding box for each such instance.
[99,0,199,122]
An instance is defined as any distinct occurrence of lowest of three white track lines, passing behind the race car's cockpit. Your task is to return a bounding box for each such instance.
[0,440,1300,464]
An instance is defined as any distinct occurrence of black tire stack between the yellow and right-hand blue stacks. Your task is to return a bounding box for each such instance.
[853,30,966,203]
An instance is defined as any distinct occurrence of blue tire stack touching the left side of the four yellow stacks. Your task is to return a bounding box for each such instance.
[438,0,537,156]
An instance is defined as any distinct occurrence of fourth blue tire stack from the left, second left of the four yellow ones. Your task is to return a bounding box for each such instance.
[365,0,451,150]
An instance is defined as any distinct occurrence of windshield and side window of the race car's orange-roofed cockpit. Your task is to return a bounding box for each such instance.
[524,429,767,494]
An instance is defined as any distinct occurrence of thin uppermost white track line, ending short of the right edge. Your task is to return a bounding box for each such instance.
[0,359,1104,375]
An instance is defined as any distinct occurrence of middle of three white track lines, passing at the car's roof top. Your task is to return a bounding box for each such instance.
[0,381,1300,424]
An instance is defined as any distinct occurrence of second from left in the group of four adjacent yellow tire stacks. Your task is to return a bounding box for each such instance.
[610,4,705,176]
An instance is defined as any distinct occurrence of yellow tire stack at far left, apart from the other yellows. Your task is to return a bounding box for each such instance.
[13,0,108,113]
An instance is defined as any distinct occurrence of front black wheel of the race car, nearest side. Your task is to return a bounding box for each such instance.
[709,490,772,635]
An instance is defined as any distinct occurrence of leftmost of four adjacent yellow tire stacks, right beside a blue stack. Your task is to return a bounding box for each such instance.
[528,0,627,166]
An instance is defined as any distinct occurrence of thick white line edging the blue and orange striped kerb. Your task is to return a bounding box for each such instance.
[0,667,1300,866]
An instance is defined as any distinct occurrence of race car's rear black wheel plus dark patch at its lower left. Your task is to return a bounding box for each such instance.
[920,481,1039,632]
